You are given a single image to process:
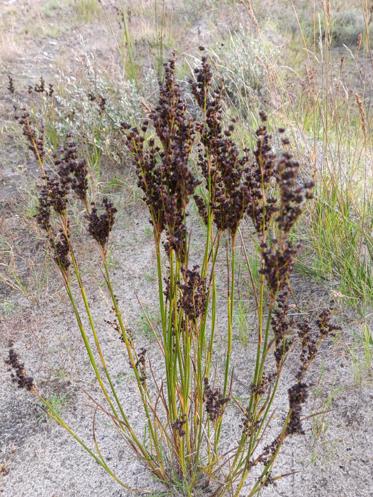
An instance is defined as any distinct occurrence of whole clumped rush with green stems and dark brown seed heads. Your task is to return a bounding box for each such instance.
[8,52,337,497]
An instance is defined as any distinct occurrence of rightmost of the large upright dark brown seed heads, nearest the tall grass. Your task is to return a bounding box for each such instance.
[247,116,314,302]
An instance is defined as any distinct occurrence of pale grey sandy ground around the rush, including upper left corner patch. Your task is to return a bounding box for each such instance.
[0,0,373,497]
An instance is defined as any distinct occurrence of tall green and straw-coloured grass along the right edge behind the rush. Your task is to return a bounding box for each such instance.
[253,2,373,309]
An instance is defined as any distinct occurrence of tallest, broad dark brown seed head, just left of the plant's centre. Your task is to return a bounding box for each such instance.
[122,57,198,261]
